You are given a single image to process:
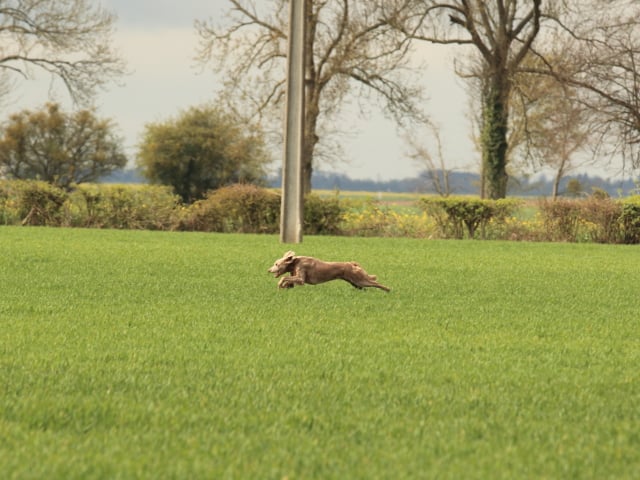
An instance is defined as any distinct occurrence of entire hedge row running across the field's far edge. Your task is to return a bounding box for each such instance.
[0,181,640,243]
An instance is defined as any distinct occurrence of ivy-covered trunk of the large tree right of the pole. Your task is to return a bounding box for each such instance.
[481,80,509,199]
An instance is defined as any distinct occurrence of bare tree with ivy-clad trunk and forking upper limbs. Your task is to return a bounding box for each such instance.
[383,0,543,198]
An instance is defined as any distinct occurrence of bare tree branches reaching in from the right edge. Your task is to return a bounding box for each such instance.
[527,0,640,172]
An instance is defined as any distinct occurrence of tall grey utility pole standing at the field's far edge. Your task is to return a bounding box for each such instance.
[280,0,307,243]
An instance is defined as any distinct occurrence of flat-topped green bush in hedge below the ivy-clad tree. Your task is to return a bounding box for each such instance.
[419,197,521,239]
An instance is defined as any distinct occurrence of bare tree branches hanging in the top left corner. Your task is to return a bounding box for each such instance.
[0,0,125,103]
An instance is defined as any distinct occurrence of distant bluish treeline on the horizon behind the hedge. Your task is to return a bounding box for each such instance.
[101,169,640,197]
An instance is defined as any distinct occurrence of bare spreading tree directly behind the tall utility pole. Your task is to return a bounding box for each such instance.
[196,0,421,192]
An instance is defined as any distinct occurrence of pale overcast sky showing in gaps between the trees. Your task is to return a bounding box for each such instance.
[8,0,478,180]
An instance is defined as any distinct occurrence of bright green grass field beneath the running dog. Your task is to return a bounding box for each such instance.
[0,227,640,479]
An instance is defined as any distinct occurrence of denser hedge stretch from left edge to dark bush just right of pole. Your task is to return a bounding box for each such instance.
[0,180,342,235]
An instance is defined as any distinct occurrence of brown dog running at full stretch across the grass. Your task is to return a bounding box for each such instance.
[269,251,391,292]
